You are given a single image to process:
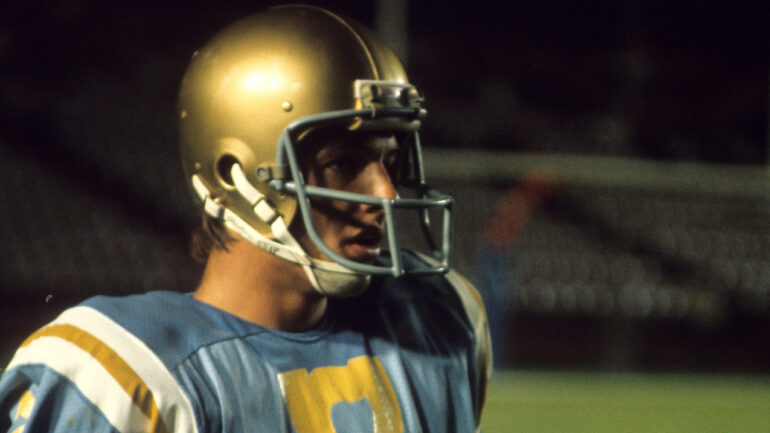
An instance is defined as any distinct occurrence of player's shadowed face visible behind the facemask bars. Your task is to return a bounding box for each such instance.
[297,132,398,263]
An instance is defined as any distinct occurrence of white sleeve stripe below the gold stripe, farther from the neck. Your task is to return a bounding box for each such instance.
[8,336,150,432]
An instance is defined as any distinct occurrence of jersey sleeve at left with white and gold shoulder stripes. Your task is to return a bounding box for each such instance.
[0,306,196,433]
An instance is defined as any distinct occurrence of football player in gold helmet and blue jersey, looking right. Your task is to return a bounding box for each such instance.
[0,6,490,433]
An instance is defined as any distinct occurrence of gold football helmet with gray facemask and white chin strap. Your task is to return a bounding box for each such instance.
[179,5,452,296]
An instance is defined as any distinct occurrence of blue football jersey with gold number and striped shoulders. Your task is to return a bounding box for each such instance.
[0,253,491,433]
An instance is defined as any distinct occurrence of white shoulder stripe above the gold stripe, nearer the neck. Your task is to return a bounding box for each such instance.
[52,306,198,433]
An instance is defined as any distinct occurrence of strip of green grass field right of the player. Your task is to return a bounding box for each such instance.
[482,370,770,433]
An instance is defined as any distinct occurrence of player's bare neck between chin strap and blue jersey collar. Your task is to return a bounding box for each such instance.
[195,240,327,332]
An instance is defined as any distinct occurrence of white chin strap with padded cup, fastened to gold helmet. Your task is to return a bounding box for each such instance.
[192,164,371,297]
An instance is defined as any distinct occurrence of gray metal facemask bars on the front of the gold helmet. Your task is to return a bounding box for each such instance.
[270,108,454,277]
